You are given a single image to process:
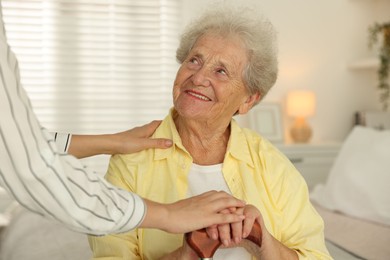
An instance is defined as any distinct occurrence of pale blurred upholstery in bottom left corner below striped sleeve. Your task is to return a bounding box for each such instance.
[0,206,92,260]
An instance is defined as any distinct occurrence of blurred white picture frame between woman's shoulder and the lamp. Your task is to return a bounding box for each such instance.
[249,103,284,143]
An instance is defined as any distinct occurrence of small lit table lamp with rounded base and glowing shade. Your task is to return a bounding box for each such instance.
[287,90,316,143]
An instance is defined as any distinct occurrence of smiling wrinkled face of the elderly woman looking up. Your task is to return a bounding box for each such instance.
[173,34,258,122]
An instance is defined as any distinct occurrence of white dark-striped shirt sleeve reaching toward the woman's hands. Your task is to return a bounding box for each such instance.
[0,5,146,235]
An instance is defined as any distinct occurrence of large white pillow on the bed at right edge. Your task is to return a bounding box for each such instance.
[311,126,390,225]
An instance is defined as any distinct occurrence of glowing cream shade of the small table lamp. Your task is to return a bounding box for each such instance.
[287,90,316,117]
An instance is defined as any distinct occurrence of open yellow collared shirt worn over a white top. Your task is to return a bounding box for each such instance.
[89,109,332,260]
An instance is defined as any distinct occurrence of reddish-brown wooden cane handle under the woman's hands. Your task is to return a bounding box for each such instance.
[185,222,262,260]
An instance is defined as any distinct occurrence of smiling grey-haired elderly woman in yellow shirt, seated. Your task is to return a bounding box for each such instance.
[89,4,330,260]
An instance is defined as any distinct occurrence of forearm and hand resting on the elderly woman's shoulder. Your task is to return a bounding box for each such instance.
[63,121,172,158]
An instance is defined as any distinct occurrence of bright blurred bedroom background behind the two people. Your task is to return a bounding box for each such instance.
[0,0,390,260]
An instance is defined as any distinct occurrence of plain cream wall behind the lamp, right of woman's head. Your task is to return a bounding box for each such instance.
[183,0,390,142]
